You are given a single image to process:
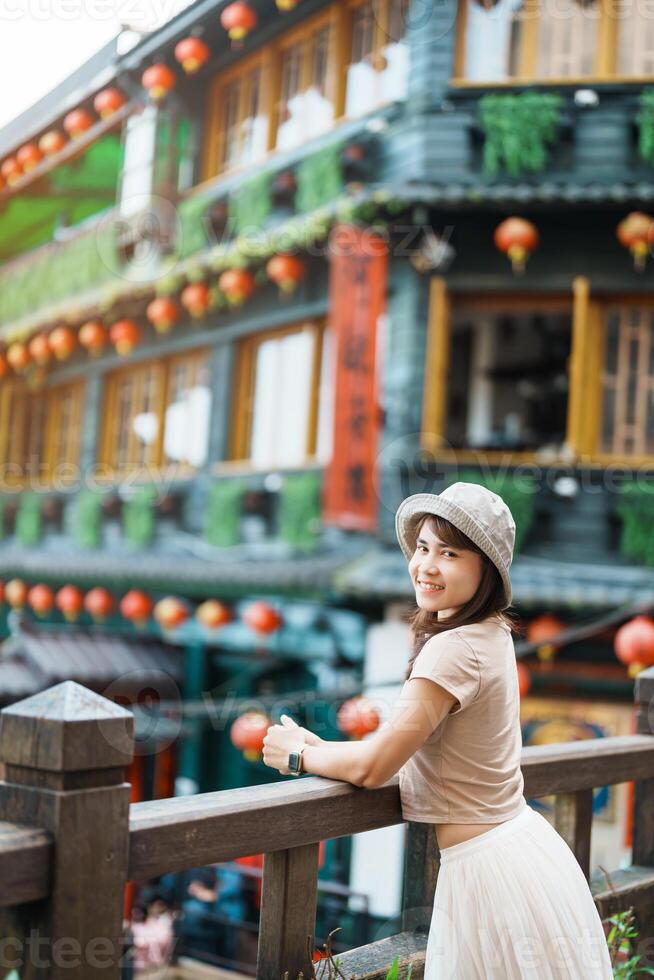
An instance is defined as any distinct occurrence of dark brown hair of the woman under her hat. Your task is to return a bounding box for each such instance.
[404,514,522,680]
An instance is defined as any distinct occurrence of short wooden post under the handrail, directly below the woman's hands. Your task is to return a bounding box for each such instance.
[257,844,318,980]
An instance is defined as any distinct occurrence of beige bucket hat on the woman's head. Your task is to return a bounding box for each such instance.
[395,483,515,606]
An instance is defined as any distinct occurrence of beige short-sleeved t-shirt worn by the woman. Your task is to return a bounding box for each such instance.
[399,615,526,824]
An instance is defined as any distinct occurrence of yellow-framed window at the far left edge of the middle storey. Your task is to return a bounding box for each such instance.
[0,382,84,484]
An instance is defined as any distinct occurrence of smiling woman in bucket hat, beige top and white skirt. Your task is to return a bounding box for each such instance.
[264,483,613,980]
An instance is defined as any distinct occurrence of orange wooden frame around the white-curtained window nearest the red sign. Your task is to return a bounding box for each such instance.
[229,317,327,470]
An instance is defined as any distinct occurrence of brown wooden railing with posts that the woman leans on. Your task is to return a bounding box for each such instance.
[0,669,654,980]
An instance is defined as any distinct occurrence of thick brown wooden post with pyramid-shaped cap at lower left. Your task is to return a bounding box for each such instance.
[0,681,133,980]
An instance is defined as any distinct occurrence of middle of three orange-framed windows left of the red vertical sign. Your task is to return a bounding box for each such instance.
[101,351,211,473]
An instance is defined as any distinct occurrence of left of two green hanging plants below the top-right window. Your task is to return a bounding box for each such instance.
[479,92,563,177]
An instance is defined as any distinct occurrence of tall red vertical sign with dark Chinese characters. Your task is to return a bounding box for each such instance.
[323,225,388,531]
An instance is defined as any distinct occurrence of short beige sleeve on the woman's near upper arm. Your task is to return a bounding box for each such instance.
[409,630,481,715]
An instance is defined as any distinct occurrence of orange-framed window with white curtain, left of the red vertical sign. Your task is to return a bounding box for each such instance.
[230,322,333,467]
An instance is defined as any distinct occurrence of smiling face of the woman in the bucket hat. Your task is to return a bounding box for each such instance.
[409,518,484,620]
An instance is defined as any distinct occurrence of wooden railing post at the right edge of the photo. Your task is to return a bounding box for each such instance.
[631,667,654,966]
